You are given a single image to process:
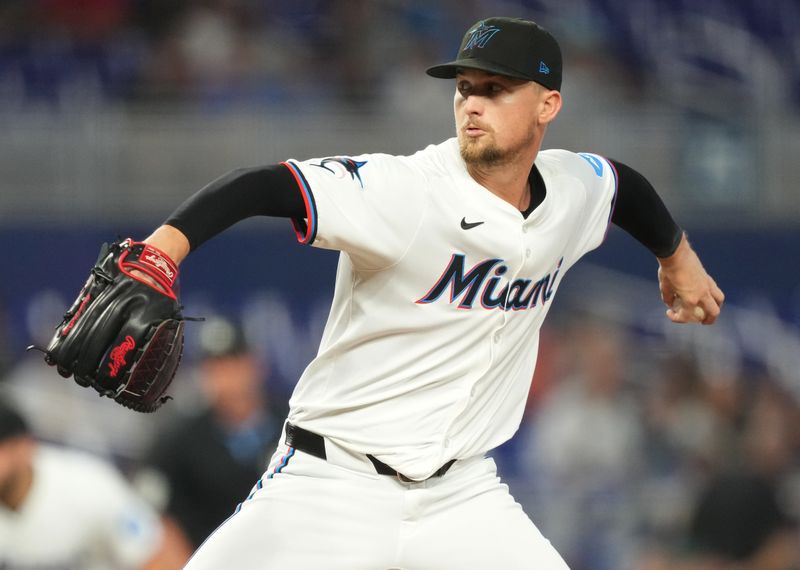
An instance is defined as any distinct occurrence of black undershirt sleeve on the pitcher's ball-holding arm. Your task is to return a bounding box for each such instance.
[611,160,683,257]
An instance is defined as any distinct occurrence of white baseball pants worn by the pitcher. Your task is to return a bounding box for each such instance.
[186,432,568,570]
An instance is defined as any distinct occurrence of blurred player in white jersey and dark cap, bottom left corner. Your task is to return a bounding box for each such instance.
[0,394,181,570]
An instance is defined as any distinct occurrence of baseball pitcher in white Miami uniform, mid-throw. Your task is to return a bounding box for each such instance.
[37,18,724,570]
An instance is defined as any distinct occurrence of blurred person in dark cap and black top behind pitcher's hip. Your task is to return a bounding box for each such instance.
[136,317,288,551]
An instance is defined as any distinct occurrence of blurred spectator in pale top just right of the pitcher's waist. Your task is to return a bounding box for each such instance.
[524,318,644,570]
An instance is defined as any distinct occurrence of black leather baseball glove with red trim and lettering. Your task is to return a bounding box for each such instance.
[33,239,184,412]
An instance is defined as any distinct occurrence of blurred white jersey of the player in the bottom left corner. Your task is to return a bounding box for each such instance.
[0,444,161,570]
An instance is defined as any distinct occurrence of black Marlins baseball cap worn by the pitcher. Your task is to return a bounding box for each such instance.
[426,18,561,90]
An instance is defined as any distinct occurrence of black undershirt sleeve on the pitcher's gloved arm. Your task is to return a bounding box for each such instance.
[164,164,306,251]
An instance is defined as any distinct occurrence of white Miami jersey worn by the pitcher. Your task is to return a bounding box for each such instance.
[286,139,616,479]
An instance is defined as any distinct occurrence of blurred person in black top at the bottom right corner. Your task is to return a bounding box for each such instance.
[685,373,800,570]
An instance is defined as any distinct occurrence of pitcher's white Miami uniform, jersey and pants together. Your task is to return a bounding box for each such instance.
[186,139,616,570]
